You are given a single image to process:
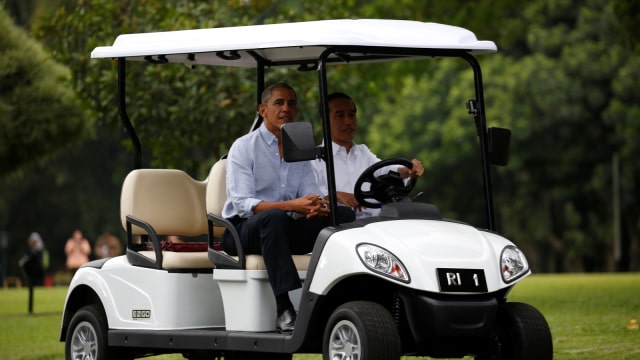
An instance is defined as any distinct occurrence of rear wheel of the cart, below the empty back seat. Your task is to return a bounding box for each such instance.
[64,304,132,360]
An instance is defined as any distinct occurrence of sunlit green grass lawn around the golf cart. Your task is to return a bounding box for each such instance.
[0,273,640,360]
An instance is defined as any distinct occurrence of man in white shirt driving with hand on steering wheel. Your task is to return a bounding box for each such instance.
[313,92,424,218]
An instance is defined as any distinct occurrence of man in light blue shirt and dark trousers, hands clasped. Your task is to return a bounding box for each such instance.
[222,83,355,333]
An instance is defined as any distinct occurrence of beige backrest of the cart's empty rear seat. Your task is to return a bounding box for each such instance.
[120,169,207,236]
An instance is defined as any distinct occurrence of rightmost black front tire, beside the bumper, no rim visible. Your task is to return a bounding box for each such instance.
[476,302,553,360]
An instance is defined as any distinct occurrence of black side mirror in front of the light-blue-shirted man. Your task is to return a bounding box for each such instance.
[280,121,321,162]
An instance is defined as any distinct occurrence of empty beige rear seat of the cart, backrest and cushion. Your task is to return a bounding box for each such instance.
[120,169,214,269]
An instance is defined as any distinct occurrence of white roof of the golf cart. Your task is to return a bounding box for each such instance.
[91,19,497,67]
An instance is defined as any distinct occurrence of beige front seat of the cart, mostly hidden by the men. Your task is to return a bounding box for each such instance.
[206,159,311,271]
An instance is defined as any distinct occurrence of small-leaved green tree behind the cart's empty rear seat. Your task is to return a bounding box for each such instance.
[35,0,316,177]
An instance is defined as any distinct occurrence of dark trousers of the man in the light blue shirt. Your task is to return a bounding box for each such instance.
[222,206,355,296]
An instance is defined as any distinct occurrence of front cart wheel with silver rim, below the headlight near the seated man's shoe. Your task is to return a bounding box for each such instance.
[322,301,402,360]
